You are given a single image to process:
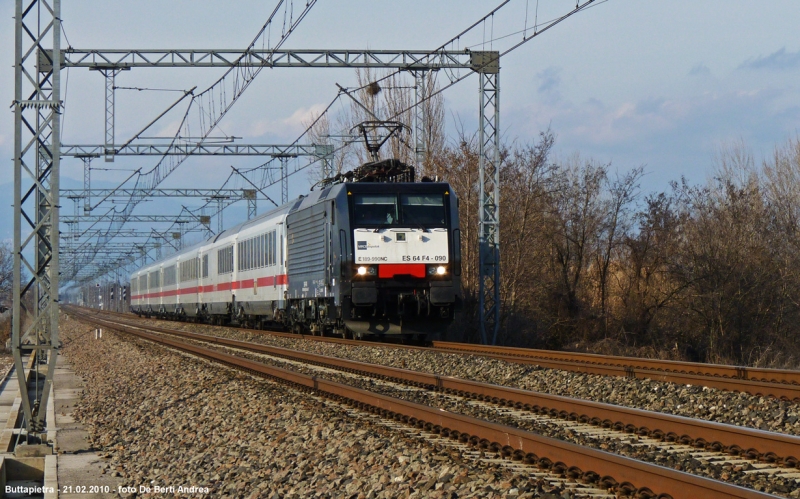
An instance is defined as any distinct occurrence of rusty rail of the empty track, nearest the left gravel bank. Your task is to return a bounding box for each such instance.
[75,312,775,499]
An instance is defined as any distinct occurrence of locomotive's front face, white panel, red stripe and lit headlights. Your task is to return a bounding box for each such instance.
[343,182,461,336]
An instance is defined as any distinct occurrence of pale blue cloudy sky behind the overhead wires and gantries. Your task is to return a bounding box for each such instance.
[0,0,800,274]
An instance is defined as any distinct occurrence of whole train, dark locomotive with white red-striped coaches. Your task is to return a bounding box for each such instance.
[130,159,463,340]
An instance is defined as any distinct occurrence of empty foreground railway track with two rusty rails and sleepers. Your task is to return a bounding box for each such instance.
[72,311,800,497]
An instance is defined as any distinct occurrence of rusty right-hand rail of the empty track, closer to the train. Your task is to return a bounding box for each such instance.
[76,312,800,467]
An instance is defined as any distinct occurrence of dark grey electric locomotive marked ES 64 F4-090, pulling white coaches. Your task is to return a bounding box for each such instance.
[286,160,461,337]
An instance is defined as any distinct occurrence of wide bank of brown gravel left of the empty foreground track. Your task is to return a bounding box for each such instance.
[60,319,580,499]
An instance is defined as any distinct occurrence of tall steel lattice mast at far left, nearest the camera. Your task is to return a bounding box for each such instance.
[11,0,62,435]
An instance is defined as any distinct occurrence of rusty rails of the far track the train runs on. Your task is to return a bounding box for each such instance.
[64,308,800,403]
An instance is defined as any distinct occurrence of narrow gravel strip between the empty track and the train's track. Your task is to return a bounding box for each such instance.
[130,315,800,435]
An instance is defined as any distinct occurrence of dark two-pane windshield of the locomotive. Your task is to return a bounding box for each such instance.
[353,193,446,227]
